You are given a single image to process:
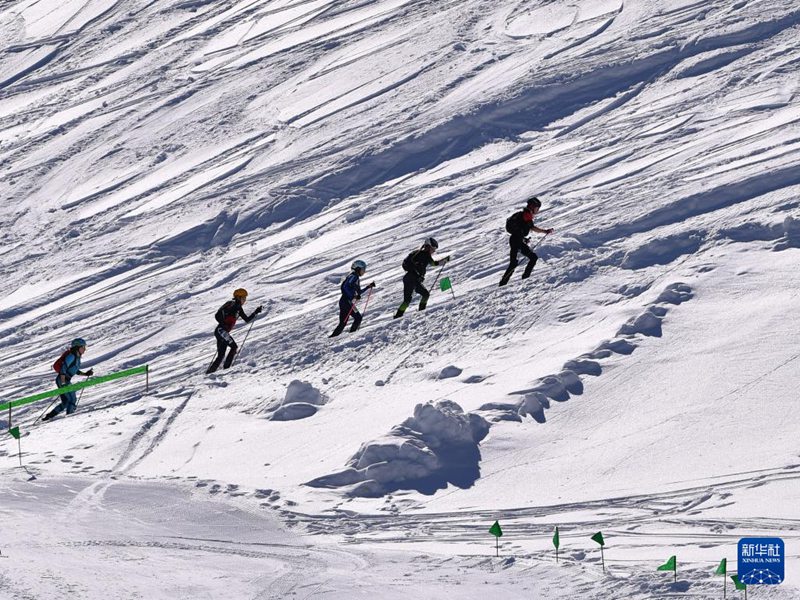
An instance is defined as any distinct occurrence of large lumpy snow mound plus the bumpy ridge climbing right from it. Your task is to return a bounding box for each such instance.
[310,282,693,498]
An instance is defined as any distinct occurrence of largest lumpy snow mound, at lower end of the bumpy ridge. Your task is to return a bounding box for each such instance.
[307,400,489,497]
